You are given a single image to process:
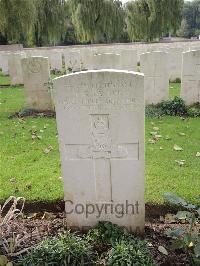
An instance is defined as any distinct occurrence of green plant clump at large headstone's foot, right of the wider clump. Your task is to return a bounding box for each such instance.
[86,222,157,266]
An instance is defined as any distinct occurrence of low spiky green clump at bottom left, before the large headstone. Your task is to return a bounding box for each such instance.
[17,232,98,266]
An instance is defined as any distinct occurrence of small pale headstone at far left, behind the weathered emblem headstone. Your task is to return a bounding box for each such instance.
[8,53,25,85]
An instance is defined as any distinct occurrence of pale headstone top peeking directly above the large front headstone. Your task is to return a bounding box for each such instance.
[92,53,121,70]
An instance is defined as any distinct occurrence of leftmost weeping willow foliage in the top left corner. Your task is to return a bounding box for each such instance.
[0,0,69,46]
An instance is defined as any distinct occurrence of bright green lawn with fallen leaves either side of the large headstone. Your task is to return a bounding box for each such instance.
[0,81,200,203]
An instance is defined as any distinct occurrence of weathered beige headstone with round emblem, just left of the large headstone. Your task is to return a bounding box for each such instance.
[22,56,53,111]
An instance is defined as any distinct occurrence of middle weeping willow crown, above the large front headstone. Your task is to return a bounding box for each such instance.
[69,0,124,42]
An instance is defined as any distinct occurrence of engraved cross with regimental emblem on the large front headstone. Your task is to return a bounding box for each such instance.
[66,114,139,202]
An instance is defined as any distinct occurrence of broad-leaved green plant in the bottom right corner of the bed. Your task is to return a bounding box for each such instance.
[164,193,200,265]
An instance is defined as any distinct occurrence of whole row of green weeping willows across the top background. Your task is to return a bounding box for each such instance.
[0,0,185,46]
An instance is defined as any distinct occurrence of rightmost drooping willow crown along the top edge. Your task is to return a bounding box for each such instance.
[126,0,184,41]
